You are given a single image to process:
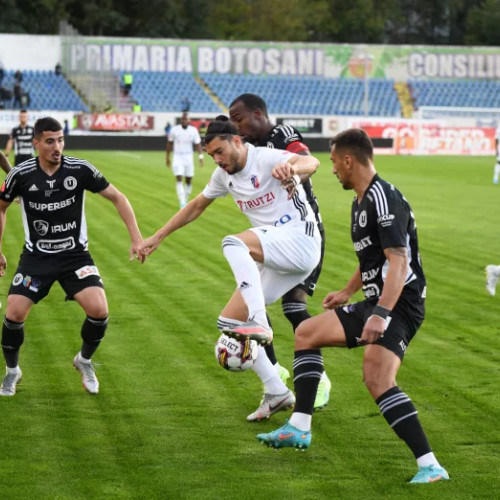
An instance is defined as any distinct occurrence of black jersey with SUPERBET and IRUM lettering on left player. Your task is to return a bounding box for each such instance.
[0,156,109,254]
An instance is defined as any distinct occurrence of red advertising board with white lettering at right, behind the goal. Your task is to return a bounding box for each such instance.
[347,119,495,156]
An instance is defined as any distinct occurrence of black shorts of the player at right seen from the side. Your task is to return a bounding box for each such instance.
[335,296,425,360]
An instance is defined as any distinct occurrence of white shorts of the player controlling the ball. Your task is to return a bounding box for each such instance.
[250,222,321,305]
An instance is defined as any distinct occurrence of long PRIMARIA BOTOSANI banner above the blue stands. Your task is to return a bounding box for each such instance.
[54,37,500,81]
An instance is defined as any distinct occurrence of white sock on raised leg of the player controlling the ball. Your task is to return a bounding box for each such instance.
[222,236,270,326]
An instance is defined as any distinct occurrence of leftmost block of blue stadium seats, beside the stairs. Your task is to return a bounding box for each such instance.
[2,70,88,111]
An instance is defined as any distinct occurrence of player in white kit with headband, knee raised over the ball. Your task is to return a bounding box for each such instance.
[141,116,321,421]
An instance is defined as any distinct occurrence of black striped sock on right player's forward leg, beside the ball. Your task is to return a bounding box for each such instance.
[293,349,324,415]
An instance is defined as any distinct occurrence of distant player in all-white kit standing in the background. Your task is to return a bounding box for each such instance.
[166,113,203,208]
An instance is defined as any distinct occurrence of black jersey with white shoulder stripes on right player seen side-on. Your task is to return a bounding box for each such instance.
[351,175,425,299]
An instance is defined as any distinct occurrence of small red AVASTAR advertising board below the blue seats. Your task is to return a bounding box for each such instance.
[77,113,155,132]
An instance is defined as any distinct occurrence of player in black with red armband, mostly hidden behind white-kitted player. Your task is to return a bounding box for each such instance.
[229,94,331,411]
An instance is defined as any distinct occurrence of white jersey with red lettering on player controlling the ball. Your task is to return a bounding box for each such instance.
[203,144,316,228]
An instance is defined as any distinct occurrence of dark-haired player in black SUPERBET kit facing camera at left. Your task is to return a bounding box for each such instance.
[0,118,144,396]
